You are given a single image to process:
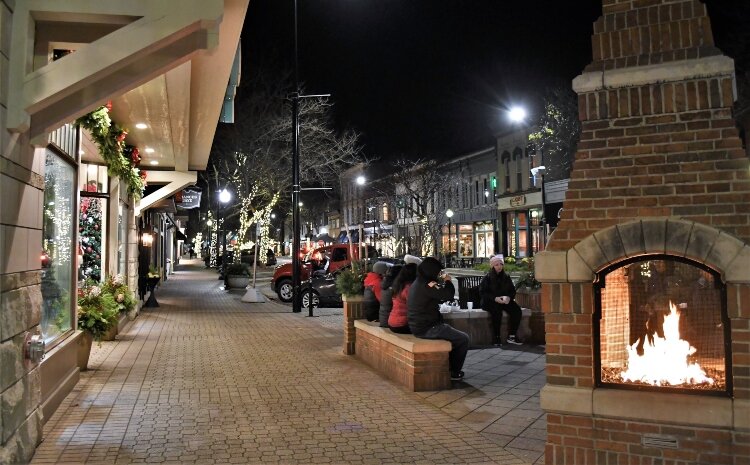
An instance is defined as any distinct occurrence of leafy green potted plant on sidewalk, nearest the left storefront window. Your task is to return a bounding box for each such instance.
[78,282,120,370]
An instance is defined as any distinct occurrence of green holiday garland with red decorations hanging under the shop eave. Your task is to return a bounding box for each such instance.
[76,102,146,200]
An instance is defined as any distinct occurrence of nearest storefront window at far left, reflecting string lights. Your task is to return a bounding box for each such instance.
[41,150,76,345]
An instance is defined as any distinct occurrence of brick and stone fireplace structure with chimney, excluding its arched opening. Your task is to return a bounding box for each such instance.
[536,0,750,465]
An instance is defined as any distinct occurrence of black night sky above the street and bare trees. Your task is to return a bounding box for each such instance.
[238,0,750,162]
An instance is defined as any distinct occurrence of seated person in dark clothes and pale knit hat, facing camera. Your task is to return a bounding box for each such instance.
[479,255,521,346]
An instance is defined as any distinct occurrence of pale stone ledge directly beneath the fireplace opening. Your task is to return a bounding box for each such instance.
[541,384,750,430]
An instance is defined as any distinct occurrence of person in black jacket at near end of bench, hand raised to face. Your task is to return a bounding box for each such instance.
[406,257,469,381]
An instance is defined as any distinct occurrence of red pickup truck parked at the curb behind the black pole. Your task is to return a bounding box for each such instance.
[271,244,377,302]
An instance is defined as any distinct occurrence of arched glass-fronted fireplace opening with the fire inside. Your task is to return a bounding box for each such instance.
[594,255,731,395]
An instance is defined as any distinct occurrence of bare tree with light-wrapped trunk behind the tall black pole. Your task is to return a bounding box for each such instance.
[209,72,363,260]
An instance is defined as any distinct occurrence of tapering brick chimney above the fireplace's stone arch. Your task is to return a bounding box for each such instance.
[548,0,750,254]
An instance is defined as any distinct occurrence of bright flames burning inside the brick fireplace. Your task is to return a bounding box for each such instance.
[620,302,714,386]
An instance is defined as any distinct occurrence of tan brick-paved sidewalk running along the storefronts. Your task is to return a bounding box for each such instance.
[32,261,543,464]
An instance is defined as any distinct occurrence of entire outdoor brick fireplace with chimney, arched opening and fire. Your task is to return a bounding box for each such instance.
[536,0,750,465]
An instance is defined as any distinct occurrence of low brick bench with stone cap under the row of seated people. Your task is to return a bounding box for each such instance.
[354,320,451,392]
